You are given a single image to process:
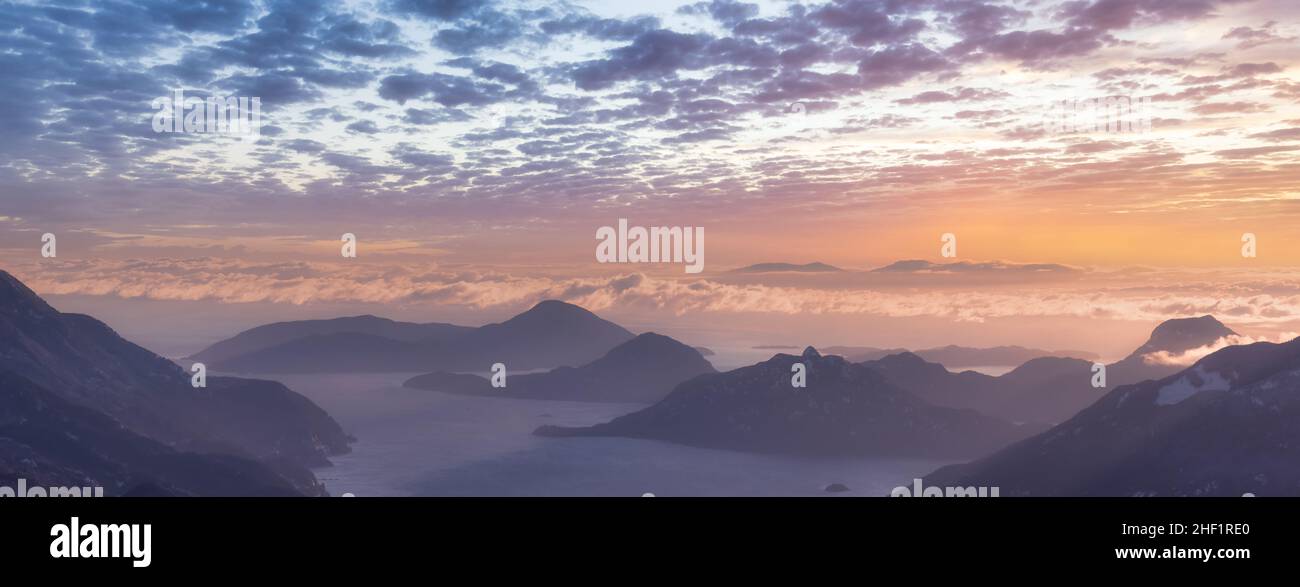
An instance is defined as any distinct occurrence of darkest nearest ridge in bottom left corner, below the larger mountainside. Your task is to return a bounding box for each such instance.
[0,371,300,496]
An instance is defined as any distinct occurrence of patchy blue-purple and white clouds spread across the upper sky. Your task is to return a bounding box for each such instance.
[0,0,1300,255]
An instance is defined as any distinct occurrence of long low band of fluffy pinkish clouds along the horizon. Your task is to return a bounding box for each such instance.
[10,257,1300,327]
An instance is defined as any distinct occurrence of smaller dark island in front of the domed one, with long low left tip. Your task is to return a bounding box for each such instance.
[404,332,716,403]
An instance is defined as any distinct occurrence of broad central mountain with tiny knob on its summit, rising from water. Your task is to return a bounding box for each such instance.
[534,347,1034,457]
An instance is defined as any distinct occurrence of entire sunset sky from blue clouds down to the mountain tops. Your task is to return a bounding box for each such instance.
[0,0,1300,355]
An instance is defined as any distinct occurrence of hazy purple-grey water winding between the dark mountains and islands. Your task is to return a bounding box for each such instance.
[276,374,944,496]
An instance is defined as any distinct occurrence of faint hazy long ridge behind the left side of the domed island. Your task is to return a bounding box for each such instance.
[189,316,473,365]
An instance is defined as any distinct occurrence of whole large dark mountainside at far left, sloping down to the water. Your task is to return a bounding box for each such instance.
[0,271,350,495]
